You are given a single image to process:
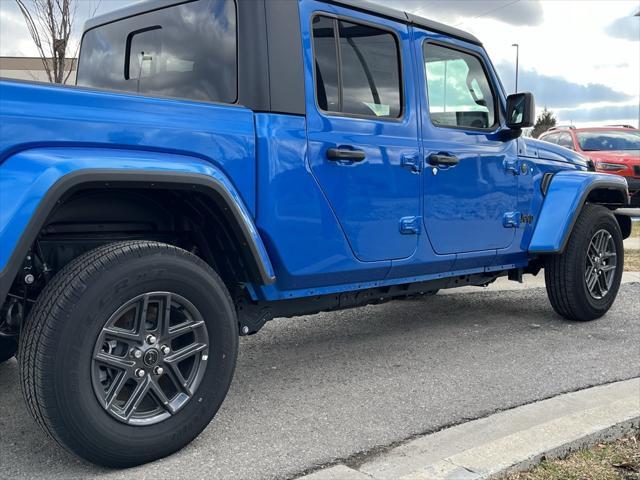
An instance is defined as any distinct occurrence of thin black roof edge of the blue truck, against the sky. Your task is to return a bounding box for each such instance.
[84,0,482,45]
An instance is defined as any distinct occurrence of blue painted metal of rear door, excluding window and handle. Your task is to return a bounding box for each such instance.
[300,1,420,262]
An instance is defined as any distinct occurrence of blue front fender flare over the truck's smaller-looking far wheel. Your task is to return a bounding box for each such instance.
[529,171,629,253]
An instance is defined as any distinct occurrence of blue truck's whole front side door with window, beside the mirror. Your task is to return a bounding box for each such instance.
[414,30,518,254]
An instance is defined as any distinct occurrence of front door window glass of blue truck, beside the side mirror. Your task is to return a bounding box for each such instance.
[423,43,496,129]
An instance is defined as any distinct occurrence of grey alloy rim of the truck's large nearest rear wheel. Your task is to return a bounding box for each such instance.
[91,292,209,425]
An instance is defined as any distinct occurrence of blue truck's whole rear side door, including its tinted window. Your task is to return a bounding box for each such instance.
[301,2,421,262]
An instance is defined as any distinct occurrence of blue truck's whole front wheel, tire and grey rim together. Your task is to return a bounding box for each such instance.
[544,204,624,321]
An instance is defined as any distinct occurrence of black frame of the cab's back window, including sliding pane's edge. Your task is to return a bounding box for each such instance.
[74,0,243,107]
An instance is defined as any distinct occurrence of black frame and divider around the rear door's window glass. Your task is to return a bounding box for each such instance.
[309,11,407,123]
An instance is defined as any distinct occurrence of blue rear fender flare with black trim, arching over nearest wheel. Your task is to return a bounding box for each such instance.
[0,147,275,299]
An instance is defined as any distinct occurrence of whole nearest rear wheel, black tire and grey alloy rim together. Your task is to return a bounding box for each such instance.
[20,241,238,467]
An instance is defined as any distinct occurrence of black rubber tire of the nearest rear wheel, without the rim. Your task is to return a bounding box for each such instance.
[19,241,238,467]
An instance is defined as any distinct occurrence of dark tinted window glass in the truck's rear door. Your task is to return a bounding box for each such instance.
[313,16,402,118]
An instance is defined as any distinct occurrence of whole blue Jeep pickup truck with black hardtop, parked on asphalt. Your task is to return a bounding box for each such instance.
[0,0,631,467]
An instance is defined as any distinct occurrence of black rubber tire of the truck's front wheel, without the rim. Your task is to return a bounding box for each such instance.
[544,204,624,321]
